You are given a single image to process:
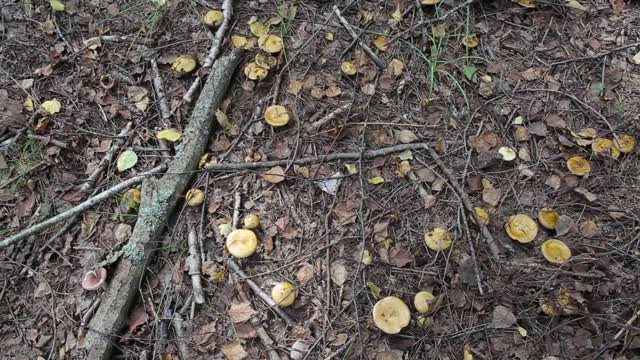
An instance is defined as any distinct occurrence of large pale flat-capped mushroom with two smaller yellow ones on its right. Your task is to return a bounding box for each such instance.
[372,291,435,334]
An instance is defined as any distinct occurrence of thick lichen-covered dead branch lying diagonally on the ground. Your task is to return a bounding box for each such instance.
[85,49,242,360]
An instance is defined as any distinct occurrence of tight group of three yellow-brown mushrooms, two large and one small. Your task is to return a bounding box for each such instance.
[505,208,571,264]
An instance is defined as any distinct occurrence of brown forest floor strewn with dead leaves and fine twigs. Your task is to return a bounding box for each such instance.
[0,0,640,360]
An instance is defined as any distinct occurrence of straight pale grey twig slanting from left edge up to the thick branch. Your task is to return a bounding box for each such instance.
[0,165,165,249]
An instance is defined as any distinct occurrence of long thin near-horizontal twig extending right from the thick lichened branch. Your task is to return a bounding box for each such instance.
[204,143,438,171]
